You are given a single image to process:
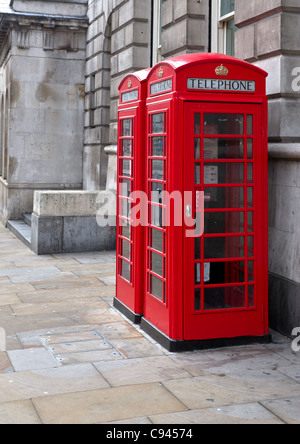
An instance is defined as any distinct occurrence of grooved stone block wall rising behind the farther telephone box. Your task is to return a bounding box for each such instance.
[83,0,151,190]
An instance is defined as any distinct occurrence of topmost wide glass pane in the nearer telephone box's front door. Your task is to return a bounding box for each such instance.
[204,114,244,135]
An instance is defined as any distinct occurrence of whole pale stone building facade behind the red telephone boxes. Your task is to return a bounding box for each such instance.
[0,0,300,335]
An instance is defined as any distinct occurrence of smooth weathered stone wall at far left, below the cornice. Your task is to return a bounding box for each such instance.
[0,9,87,223]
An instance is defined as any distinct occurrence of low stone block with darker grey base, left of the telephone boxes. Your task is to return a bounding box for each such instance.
[30,191,116,254]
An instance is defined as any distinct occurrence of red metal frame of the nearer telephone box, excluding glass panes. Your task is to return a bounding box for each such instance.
[144,54,268,341]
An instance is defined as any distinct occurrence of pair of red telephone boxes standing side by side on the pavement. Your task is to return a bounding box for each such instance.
[114,54,270,351]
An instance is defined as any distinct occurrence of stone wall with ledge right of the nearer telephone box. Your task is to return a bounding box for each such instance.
[235,0,300,335]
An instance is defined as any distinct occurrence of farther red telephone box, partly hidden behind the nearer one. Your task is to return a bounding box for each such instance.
[114,69,150,323]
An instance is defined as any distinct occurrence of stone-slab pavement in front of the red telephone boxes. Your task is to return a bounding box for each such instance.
[0,226,300,424]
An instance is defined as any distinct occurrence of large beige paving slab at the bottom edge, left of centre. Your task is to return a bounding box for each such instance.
[32,383,187,424]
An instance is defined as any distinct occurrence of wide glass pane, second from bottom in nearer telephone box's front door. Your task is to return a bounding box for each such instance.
[204,261,245,285]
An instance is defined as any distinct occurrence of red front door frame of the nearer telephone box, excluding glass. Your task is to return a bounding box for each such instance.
[184,103,268,340]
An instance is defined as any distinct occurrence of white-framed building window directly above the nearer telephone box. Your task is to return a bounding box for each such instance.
[211,0,237,56]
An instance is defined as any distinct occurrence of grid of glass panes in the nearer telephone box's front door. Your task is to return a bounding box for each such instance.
[192,109,255,312]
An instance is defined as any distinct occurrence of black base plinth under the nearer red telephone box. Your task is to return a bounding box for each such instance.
[141,318,272,353]
